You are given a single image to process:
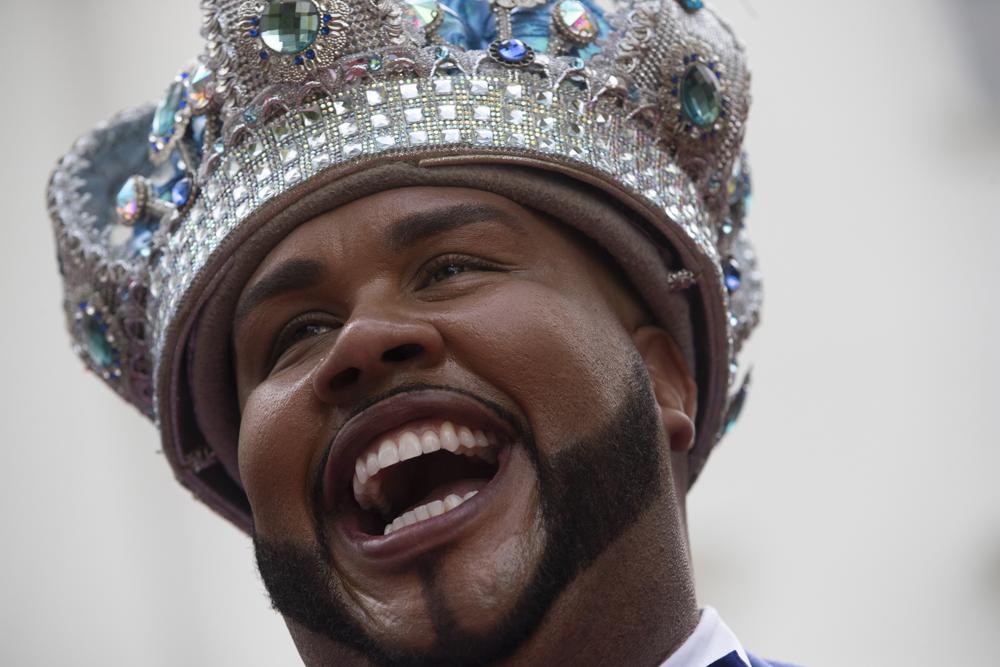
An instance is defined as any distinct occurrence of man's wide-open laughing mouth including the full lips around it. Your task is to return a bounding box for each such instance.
[324,390,515,556]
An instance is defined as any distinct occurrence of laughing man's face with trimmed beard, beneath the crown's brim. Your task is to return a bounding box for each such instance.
[233,188,688,664]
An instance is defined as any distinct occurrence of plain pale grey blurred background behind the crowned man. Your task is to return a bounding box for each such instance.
[0,0,1000,666]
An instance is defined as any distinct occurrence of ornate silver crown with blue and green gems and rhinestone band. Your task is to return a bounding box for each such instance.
[49,0,761,532]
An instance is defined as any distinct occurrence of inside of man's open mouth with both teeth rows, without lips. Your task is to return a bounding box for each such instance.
[351,421,501,535]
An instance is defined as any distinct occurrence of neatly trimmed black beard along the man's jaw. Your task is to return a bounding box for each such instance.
[254,353,662,667]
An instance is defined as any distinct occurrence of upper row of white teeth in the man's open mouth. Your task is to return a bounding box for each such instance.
[353,421,497,513]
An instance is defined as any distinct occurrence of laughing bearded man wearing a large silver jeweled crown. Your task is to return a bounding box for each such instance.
[50,0,780,667]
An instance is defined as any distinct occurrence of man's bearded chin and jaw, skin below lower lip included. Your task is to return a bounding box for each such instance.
[254,360,662,667]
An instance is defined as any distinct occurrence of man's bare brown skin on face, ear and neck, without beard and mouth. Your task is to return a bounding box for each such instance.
[233,187,698,665]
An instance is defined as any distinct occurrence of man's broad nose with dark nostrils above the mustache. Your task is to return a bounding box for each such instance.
[312,316,444,403]
